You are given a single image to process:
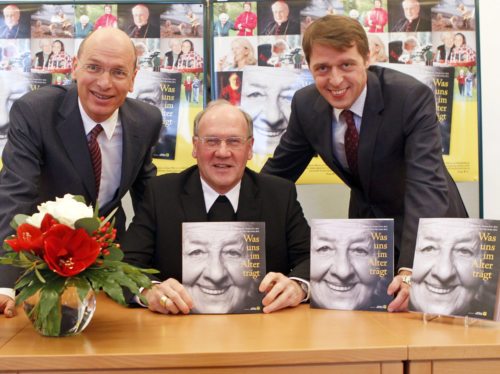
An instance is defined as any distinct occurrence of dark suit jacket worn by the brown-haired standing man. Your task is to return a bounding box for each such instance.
[262,66,467,267]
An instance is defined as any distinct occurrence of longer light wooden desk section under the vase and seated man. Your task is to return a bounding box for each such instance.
[0,295,407,374]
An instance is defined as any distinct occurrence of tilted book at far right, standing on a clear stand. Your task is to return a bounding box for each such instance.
[409,218,500,320]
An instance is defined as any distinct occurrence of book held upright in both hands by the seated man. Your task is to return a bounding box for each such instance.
[182,222,266,314]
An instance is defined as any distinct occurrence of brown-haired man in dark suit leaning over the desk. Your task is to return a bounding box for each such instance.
[262,15,467,311]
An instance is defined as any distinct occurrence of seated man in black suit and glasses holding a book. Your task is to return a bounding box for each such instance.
[122,100,310,314]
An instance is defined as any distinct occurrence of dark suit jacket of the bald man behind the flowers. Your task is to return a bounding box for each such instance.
[0,85,162,287]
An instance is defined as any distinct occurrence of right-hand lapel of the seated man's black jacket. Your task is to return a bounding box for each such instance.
[236,169,262,222]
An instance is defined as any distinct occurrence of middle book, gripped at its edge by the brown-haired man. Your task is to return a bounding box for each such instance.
[311,219,394,311]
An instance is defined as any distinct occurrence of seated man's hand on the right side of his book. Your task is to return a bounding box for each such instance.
[259,272,306,313]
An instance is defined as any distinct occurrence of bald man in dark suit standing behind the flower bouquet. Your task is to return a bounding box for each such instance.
[0,28,162,316]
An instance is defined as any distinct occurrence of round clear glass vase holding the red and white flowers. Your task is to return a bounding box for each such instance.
[23,287,96,336]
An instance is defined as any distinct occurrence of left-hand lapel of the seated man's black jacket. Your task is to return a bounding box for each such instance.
[181,166,207,222]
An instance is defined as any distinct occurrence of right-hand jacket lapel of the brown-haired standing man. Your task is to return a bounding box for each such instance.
[358,70,384,194]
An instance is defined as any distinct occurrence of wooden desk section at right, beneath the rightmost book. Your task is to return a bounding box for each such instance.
[374,313,500,374]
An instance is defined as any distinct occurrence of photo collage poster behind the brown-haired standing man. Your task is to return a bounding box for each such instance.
[210,0,479,183]
